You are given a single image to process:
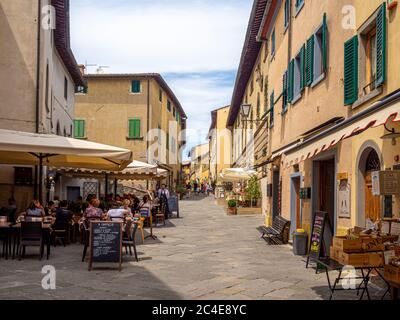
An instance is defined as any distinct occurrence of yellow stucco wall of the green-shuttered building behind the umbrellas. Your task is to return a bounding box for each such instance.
[75,77,181,183]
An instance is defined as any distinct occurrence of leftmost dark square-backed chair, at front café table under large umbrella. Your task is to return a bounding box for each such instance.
[18,221,43,260]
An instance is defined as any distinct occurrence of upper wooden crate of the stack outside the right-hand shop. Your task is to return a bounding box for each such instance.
[333,237,385,253]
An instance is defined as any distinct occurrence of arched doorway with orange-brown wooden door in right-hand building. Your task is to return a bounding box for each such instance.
[357,146,382,227]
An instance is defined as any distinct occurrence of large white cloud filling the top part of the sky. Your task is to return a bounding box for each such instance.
[71,0,251,73]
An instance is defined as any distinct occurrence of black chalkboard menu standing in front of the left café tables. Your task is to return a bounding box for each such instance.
[89,221,122,271]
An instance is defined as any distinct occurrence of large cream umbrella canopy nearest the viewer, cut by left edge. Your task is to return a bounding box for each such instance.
[0,129,133,171]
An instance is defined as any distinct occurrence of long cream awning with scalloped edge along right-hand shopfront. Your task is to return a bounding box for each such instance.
[283,102,400,166]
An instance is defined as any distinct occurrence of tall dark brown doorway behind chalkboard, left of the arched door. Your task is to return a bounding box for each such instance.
[313,157,336,254]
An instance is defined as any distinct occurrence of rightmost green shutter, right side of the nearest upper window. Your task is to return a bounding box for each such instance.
[376,2,386,86]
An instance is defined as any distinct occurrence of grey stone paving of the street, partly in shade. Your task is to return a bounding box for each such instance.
[0,196,390,300]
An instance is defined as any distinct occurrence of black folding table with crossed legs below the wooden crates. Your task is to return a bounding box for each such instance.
[316,257,376,300]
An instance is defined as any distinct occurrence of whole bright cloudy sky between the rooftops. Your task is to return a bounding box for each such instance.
[70,0,253,159]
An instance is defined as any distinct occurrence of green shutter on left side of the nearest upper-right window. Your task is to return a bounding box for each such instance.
[344,36,358,105]
